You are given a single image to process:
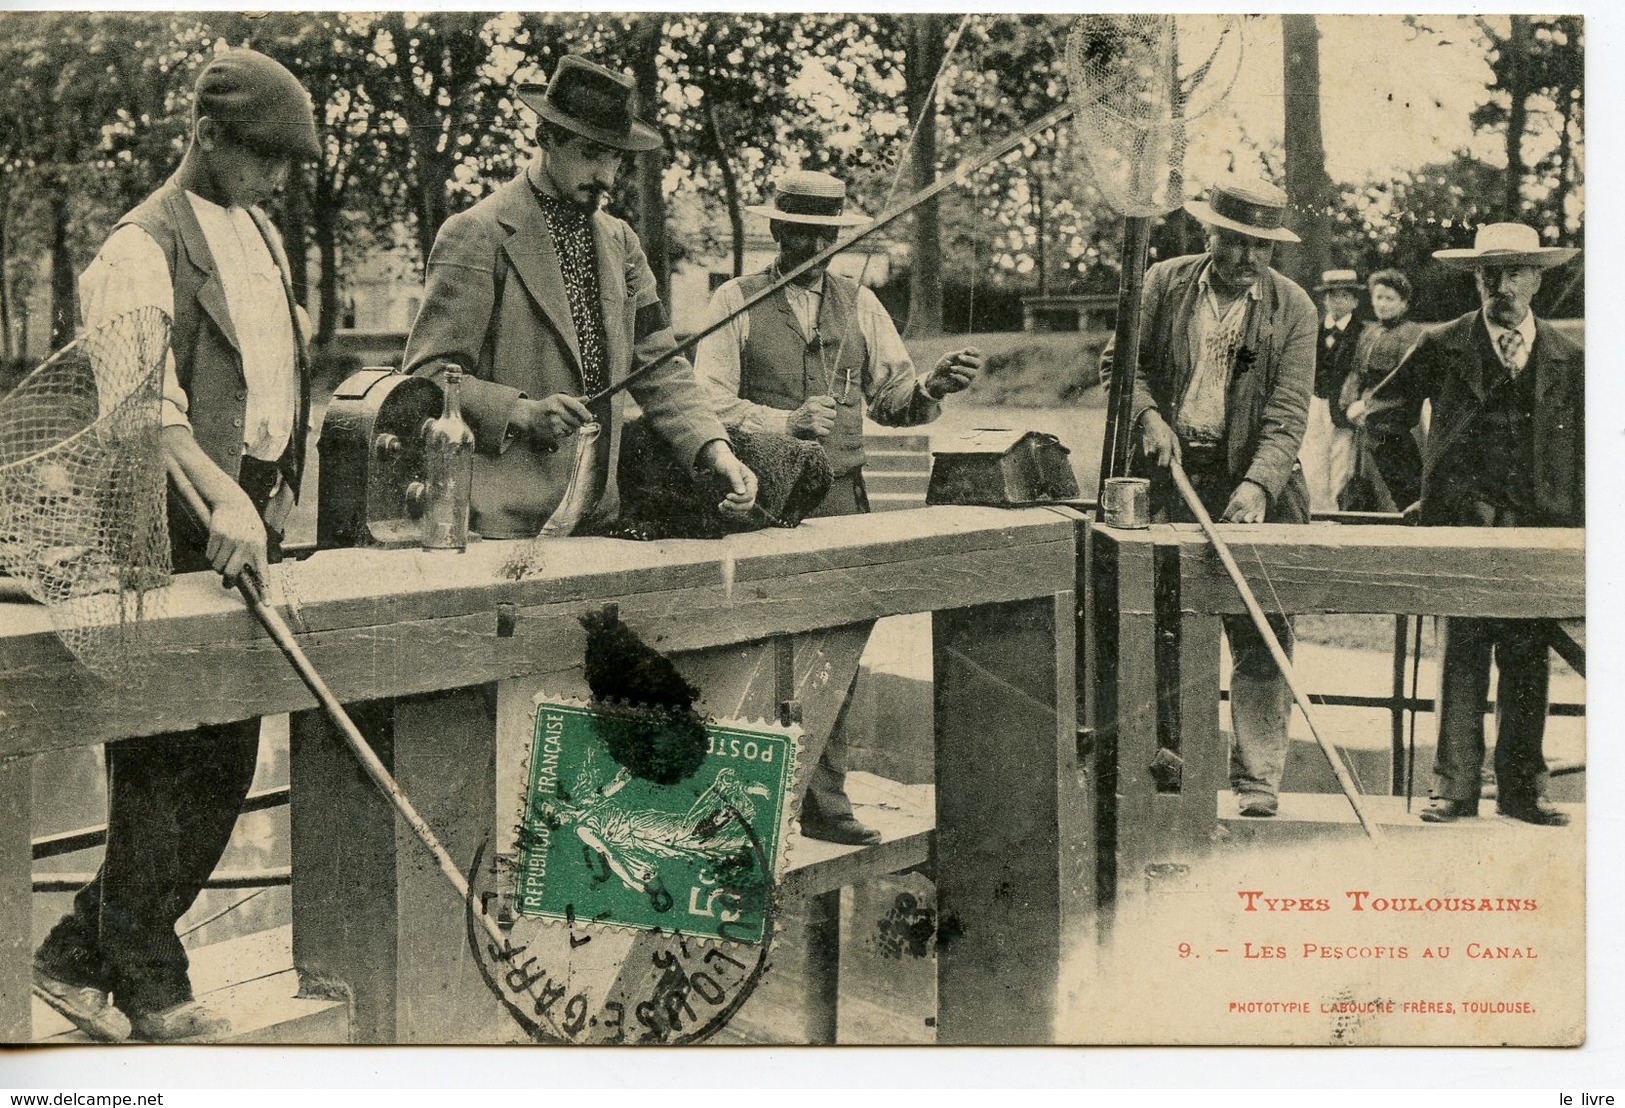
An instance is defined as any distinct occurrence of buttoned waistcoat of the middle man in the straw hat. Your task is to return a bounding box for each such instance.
[739,273,869,476]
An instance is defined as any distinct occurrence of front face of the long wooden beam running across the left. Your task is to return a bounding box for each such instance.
[0,535,1073,757]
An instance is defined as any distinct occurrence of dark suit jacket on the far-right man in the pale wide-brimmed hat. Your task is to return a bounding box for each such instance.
[1389,312,1586,526]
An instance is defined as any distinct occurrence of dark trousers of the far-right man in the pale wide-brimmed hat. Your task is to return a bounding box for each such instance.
[1433,617,1550,804]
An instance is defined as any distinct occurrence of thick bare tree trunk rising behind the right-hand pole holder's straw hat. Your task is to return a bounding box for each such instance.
[1281,15,1333,297]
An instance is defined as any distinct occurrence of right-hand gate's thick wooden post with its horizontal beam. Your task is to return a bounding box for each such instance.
[1079,523,1586,910]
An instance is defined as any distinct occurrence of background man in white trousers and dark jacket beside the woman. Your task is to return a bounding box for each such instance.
[1298,270,1360,512]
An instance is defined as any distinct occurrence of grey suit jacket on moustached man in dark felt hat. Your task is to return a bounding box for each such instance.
[405,167,728,538]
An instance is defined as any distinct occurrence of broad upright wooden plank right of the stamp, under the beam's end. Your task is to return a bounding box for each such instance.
[933,590,1087,1043]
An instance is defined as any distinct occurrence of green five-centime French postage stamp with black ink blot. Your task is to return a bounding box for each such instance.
[512,697,796,944]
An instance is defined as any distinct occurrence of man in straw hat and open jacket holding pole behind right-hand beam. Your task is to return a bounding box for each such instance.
[1133,177,1318,817]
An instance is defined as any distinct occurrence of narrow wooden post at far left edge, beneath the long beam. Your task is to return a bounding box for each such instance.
[0,757,34,1043]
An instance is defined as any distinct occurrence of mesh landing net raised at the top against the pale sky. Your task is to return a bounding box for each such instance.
[1066,13,1242,216]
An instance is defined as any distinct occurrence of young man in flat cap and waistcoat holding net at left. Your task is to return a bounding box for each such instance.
[34,50,320,1043]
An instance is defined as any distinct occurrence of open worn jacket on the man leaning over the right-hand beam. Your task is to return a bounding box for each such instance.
[1133,253,1320,522]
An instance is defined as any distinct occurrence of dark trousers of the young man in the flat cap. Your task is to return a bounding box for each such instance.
[34,460,280,1015]
